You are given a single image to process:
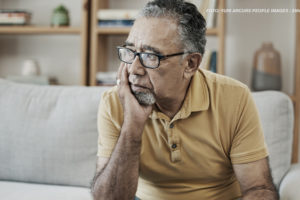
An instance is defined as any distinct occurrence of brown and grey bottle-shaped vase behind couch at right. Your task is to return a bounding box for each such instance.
[252,42,281,91]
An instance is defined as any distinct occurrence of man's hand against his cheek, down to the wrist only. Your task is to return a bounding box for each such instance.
[118,62,152,128]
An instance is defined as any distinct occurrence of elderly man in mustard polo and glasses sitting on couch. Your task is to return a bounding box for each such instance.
[92,0,278,200]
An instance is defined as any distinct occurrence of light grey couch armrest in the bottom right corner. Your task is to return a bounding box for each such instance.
[279,163,300,200]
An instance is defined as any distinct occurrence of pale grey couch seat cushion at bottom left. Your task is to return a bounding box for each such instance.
[0,181,92,200]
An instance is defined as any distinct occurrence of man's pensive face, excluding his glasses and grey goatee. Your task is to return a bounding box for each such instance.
[126,18,188,104]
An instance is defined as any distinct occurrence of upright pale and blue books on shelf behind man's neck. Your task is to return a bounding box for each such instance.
[200,50,218,73]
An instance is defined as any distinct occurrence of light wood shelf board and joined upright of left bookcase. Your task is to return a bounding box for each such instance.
[0,0,89,85]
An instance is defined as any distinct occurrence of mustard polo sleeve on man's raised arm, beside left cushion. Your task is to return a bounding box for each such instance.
[97,89,121,157]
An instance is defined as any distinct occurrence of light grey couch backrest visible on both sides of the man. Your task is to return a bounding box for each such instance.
[0,79,294,187]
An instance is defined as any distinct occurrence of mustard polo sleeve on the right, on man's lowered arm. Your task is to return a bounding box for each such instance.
[230,89,268,164]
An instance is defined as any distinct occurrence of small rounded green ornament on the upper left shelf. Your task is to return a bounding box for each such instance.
[51,5,70,26]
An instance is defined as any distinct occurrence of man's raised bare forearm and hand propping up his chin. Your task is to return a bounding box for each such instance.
[91,63,152,200]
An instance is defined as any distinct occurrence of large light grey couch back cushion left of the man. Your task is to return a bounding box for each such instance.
[0,80,112,186]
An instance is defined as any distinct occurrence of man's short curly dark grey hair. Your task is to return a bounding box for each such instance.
[139,0,206,55]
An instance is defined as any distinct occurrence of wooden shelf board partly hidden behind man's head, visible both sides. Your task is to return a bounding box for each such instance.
[96,26,219,36]
